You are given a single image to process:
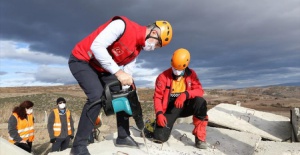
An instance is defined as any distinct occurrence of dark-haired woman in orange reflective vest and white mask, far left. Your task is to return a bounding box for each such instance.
[8,100,34,153]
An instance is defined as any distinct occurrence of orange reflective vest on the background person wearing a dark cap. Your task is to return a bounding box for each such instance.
[53,108,72,137]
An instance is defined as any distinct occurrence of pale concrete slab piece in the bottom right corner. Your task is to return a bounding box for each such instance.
[254,141,300,155]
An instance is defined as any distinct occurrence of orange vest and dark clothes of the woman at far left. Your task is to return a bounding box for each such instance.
[8,113,34,153]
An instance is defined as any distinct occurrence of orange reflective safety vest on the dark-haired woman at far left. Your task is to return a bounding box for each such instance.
[8,113,34,144]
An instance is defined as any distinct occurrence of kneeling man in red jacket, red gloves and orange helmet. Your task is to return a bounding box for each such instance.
[153,48,208,149]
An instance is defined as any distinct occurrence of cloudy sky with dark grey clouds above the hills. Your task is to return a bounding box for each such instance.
[0,0,300,89]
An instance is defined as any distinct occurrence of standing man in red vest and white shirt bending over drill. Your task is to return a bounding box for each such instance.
[69,16,172,155]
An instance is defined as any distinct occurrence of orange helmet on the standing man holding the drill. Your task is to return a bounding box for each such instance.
[155,20,173,46]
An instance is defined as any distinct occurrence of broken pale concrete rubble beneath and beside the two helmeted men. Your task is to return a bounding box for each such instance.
[0,104,300,155]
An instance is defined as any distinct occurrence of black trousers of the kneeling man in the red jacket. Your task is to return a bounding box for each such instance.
[154,97,207,142]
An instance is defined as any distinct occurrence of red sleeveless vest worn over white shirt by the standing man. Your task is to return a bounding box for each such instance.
[72,16,146,72]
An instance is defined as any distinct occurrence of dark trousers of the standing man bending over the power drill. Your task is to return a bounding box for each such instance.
[69,55,130,147]
